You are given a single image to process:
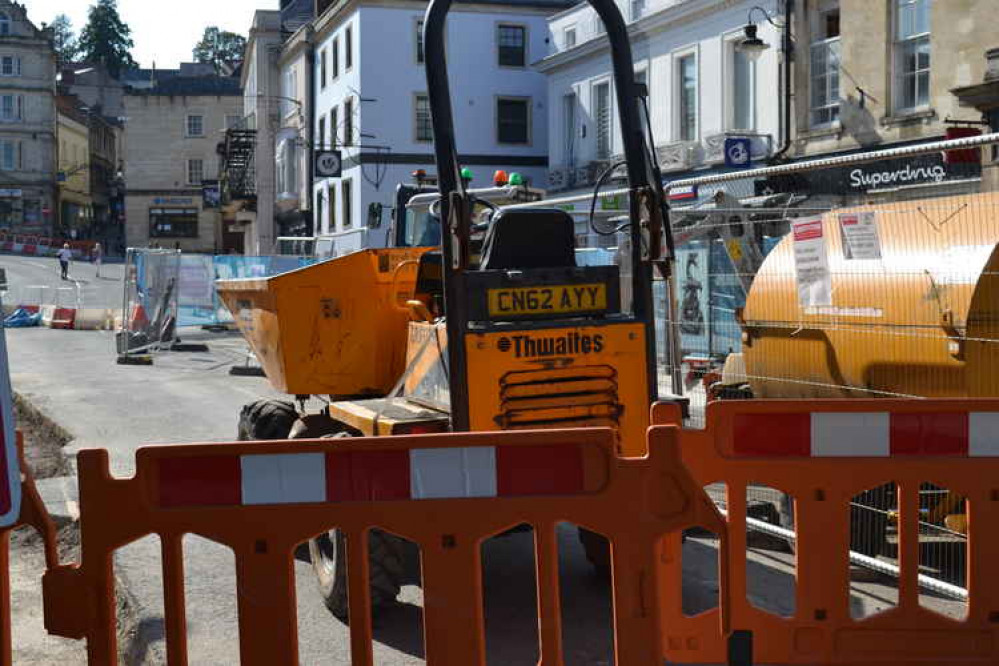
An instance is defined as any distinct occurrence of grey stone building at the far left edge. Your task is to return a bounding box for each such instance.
[0,0,56,235]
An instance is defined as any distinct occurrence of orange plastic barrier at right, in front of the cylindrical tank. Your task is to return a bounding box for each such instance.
[652,400,999,666]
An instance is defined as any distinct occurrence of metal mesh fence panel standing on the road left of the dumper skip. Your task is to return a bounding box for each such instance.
[116,248,180,355]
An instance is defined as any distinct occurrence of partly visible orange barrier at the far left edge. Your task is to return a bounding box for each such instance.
[0,432,59,666]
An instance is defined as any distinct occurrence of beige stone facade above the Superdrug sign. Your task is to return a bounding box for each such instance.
[791,0,999,156]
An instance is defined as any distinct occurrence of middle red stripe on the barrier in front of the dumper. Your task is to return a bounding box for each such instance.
[326,451,409,502]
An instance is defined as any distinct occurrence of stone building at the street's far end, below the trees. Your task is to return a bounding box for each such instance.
[123,66,243,252]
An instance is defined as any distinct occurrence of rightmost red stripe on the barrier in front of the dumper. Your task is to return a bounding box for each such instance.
[496,444,584,497]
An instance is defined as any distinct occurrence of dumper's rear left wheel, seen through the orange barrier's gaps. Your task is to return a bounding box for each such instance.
[309,530,406,621]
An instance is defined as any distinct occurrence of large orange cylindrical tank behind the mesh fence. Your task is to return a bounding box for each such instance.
[743,193,999,398]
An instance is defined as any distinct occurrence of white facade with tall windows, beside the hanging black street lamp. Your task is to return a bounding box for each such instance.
[536,0,784,191]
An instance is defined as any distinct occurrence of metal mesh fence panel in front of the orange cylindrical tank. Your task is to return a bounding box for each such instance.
[657,132,999,594]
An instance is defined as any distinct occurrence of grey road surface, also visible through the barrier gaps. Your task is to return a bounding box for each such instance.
[0,252,964,666]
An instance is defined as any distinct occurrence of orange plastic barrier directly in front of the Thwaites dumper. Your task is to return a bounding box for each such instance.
[43,428,726,666]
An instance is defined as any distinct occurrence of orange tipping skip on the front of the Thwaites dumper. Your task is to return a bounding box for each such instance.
[217,248,430,397]
